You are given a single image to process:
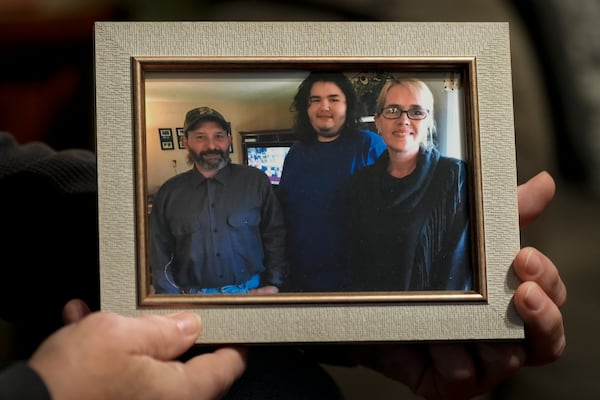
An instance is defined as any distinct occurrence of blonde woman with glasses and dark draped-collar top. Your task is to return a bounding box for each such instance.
[350,79,473,291]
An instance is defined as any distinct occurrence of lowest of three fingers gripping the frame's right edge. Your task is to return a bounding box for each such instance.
[514,282,566,365]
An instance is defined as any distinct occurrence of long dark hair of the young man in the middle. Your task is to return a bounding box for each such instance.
[292,71,363,142]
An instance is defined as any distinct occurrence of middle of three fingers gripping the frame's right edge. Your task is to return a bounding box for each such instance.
[513,247,567,308]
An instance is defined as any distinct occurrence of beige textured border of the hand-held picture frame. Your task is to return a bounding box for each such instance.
[95,22,523,343]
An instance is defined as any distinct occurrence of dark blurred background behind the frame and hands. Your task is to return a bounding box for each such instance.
[0,0,600,399]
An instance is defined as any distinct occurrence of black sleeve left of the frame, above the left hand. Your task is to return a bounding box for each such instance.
[0,132,100,359]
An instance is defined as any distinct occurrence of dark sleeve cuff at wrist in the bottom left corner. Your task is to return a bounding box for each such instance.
[0,361,51,400]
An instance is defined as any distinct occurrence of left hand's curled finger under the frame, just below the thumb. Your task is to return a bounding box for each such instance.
[184,347,248,399]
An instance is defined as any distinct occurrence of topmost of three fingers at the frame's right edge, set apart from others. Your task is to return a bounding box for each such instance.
[517,171,556,228]
